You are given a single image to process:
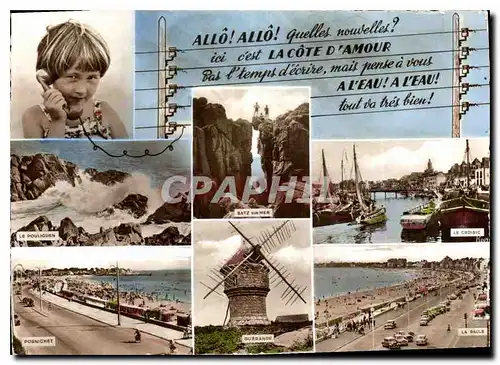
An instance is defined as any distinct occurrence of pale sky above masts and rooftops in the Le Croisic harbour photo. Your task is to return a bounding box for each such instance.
[311,138,490,182]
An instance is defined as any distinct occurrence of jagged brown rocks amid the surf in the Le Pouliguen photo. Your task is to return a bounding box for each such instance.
[10,154,191,247]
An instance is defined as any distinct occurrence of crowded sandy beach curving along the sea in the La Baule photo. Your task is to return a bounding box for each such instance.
[315,270,453,322]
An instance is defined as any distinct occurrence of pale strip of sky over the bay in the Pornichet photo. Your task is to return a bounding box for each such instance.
[11,246,191,270]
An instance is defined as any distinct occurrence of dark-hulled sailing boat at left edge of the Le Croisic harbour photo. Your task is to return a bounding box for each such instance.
[313,150,354,227]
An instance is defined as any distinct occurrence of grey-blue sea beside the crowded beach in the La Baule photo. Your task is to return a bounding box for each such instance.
[314,267,417,299]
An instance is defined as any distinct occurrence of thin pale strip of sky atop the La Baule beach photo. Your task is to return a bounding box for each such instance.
[314,242,490,263]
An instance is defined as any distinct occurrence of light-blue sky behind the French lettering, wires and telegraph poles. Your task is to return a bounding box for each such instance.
[135,11,490,139]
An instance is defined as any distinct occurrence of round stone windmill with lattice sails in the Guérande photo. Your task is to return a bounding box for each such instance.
[201,221,307,326]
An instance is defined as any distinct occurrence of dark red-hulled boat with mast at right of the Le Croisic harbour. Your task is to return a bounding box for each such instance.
[440,140,490,240]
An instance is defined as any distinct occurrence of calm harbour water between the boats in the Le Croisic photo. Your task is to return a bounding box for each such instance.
[313,193,441,244]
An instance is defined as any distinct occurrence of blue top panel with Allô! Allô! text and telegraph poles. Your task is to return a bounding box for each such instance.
[135,10,491,140]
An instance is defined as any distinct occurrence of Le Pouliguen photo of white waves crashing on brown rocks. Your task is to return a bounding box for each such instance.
[10,140,191,247]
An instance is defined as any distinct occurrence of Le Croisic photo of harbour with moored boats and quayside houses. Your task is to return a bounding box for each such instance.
[311,138,491,244]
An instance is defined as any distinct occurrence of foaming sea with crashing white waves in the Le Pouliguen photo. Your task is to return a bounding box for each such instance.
[11,140,191,237]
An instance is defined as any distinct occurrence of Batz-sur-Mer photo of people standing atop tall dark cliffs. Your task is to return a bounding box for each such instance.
[192,87,311,219]
